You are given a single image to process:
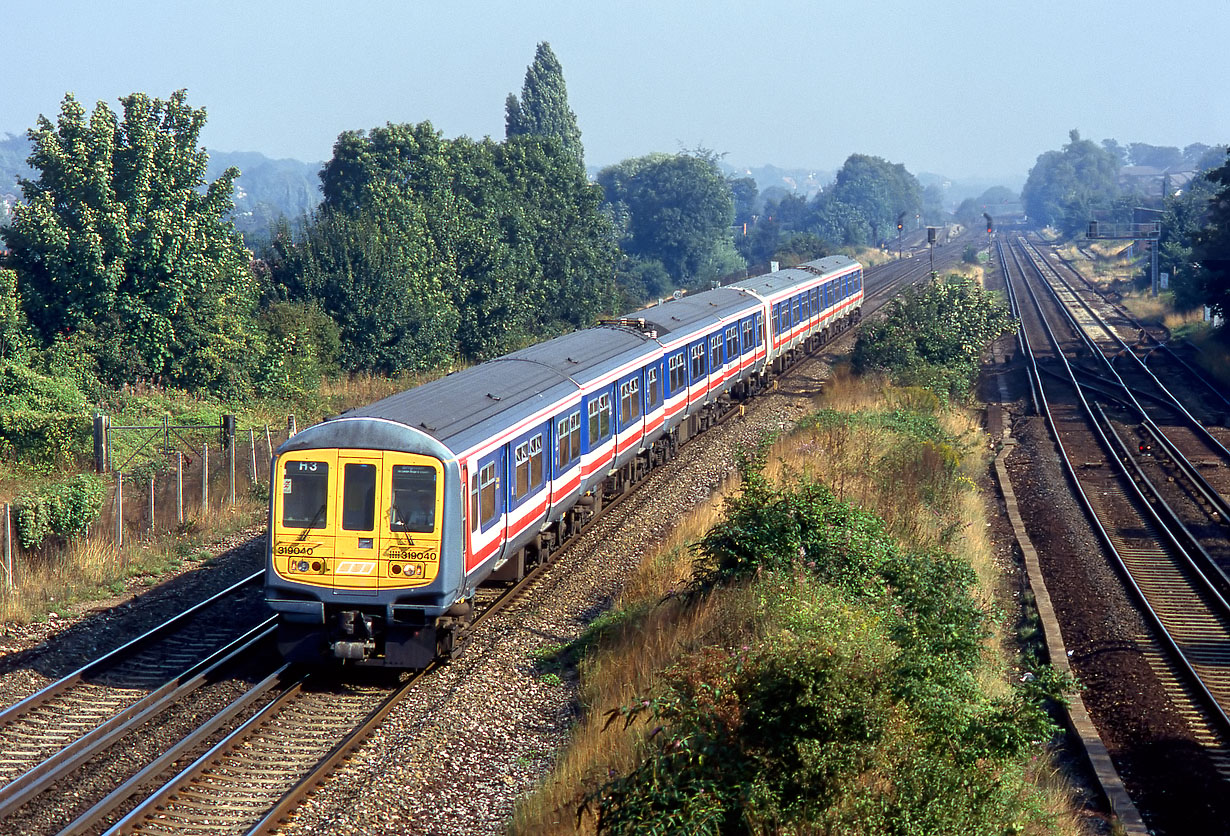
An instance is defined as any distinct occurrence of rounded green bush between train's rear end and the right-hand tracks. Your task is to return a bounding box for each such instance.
[852,274,1015,400]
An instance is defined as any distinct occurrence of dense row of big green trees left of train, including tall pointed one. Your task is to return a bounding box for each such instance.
[0,44,617,410]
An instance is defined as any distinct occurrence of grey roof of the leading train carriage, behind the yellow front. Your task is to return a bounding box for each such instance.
[341,327,657,452]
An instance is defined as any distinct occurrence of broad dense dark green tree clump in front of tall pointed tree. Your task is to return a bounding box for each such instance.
[264,122,615,373]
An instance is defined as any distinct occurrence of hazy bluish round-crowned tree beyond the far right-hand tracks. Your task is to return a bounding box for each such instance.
[1021,130,1119,236]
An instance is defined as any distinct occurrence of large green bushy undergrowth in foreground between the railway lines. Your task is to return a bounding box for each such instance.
[583,466,1071,835]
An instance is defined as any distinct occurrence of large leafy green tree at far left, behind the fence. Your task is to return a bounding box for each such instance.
[2,90,255,391]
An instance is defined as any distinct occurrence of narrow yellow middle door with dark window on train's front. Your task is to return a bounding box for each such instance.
[333,452,383,595]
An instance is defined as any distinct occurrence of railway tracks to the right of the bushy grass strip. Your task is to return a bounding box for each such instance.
[999,234,1230,779]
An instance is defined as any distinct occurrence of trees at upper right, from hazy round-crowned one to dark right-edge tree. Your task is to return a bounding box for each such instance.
[1021,130,1230,317]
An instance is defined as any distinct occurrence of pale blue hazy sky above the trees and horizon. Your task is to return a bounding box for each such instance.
[0,0,1230,179]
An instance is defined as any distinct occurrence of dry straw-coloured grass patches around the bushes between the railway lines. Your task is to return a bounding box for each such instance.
[510,373,1081,835]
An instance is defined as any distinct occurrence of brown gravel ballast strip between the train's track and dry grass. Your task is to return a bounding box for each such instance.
[283,359,828,836]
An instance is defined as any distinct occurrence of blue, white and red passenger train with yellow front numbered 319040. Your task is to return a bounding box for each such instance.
[264,256,863,669]
